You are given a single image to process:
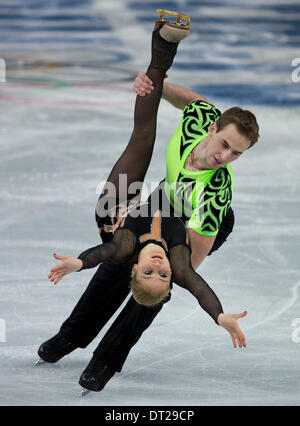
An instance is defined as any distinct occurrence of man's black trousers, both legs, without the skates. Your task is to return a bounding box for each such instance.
[60,209,234,371]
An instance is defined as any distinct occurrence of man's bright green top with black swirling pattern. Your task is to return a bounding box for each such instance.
[165,100,233,235]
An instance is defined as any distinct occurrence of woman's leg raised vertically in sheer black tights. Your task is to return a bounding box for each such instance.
[96,16,188,213]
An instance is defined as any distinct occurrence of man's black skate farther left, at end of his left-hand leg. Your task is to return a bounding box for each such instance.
[36,333,78,365]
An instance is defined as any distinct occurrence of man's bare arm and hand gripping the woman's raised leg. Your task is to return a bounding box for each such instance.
[133,72,211,110]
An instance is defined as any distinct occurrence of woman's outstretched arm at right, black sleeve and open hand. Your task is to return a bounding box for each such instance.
[170,245,247,348]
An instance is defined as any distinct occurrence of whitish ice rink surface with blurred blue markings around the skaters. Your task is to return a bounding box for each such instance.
[0,0,300,406]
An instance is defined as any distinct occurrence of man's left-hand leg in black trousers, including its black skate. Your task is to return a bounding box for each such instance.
[38,262,131,363]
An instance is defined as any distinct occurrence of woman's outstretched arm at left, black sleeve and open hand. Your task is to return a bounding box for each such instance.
[48,228,136,284]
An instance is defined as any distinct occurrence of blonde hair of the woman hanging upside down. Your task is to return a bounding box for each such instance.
[130,272,170,306]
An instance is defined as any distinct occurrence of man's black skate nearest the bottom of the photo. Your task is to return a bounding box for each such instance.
[79,355,115,396]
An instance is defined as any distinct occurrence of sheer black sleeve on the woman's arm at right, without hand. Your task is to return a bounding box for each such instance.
[169,244,223,324]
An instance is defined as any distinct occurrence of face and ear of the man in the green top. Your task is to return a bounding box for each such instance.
[206,123,250,169]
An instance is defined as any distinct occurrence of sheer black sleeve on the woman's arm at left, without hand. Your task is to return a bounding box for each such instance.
[78,228,136,270]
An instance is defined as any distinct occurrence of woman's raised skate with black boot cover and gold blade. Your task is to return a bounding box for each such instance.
[150,9,190,72]
